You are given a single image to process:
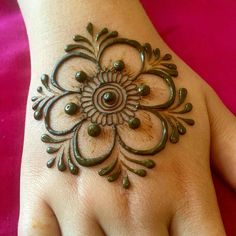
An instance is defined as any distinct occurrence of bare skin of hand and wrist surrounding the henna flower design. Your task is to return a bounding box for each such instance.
[19,0,236,236]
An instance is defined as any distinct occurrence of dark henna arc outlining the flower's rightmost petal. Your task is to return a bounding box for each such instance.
[139,70,176,109]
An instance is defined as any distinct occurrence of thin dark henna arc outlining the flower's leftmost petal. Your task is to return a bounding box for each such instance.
[44,91,85,136]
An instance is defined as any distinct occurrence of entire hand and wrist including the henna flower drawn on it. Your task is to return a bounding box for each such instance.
[19,0,236,236]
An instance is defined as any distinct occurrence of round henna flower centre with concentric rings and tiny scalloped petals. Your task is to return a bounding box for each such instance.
[80,71,140,125]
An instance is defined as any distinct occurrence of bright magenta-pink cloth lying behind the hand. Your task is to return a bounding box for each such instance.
[0,0,236,236]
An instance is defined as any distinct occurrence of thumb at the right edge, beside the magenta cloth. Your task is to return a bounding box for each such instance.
[206,85,236,190]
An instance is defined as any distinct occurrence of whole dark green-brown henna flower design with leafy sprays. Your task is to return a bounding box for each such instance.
[32,23,194,188]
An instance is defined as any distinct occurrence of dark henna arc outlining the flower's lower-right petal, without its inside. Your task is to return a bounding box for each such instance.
[117,110,168,156]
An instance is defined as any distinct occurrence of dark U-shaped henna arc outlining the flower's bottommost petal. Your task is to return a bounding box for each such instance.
[72,122,117,167]
